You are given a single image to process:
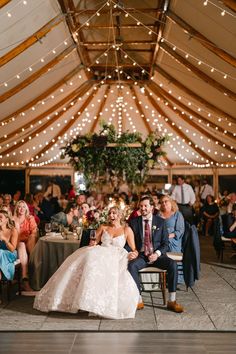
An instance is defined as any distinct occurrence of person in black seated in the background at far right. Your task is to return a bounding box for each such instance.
[202,194,220,236]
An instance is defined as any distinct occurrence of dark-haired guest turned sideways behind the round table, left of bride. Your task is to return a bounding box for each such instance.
[51,202,79,227]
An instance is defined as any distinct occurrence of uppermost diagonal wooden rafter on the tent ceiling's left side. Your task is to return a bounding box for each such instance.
[0,15,63,67]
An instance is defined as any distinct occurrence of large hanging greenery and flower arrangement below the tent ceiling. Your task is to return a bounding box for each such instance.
[61,122,168,185]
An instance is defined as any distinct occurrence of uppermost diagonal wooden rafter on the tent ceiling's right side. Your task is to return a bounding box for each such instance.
[167,10,236,67]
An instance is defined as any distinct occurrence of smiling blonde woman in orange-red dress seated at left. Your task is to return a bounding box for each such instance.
[13,200,38,291]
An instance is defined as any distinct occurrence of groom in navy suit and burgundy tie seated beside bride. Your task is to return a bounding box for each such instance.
[128,196,184,313]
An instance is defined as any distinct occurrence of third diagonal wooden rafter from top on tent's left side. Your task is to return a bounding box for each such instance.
[1,82,91,156]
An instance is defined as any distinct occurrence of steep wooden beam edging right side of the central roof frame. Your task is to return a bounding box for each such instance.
[149,0,169,77]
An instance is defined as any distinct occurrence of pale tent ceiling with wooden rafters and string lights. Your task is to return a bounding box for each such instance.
[0,0,236,171]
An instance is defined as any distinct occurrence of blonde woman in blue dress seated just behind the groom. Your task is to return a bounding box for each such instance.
[159,195,185,283]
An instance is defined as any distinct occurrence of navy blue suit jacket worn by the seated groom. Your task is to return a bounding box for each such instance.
[129,215,169,254]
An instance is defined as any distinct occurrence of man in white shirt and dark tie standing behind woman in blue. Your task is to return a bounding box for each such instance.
[171,176,196,224]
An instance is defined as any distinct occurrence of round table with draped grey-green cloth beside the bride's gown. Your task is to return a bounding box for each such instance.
[29,235,80,290]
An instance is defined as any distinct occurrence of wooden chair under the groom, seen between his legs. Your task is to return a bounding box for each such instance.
[139,267,166,305]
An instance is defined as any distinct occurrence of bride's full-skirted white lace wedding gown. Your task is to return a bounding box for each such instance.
[34,232,139,319]
